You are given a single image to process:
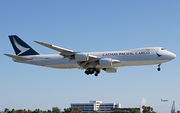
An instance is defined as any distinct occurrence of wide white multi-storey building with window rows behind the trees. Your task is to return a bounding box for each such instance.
[71,101,121,113]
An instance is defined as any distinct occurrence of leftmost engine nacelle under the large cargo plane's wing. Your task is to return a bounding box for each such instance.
[74,53,89,61]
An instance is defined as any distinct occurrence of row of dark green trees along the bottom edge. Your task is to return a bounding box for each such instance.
[4,106,156,113]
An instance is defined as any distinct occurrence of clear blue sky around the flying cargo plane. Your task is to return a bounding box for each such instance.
[0,0,180,113]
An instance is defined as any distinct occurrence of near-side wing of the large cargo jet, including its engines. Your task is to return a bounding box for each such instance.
[35,41,120,69]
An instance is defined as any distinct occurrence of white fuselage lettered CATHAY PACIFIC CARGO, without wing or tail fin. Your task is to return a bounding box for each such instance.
[13,47,176,69]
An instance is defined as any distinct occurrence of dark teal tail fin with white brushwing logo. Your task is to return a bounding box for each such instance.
[9,35,39,56]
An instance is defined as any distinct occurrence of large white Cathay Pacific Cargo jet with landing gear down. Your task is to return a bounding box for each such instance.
[4,35,176,76]
